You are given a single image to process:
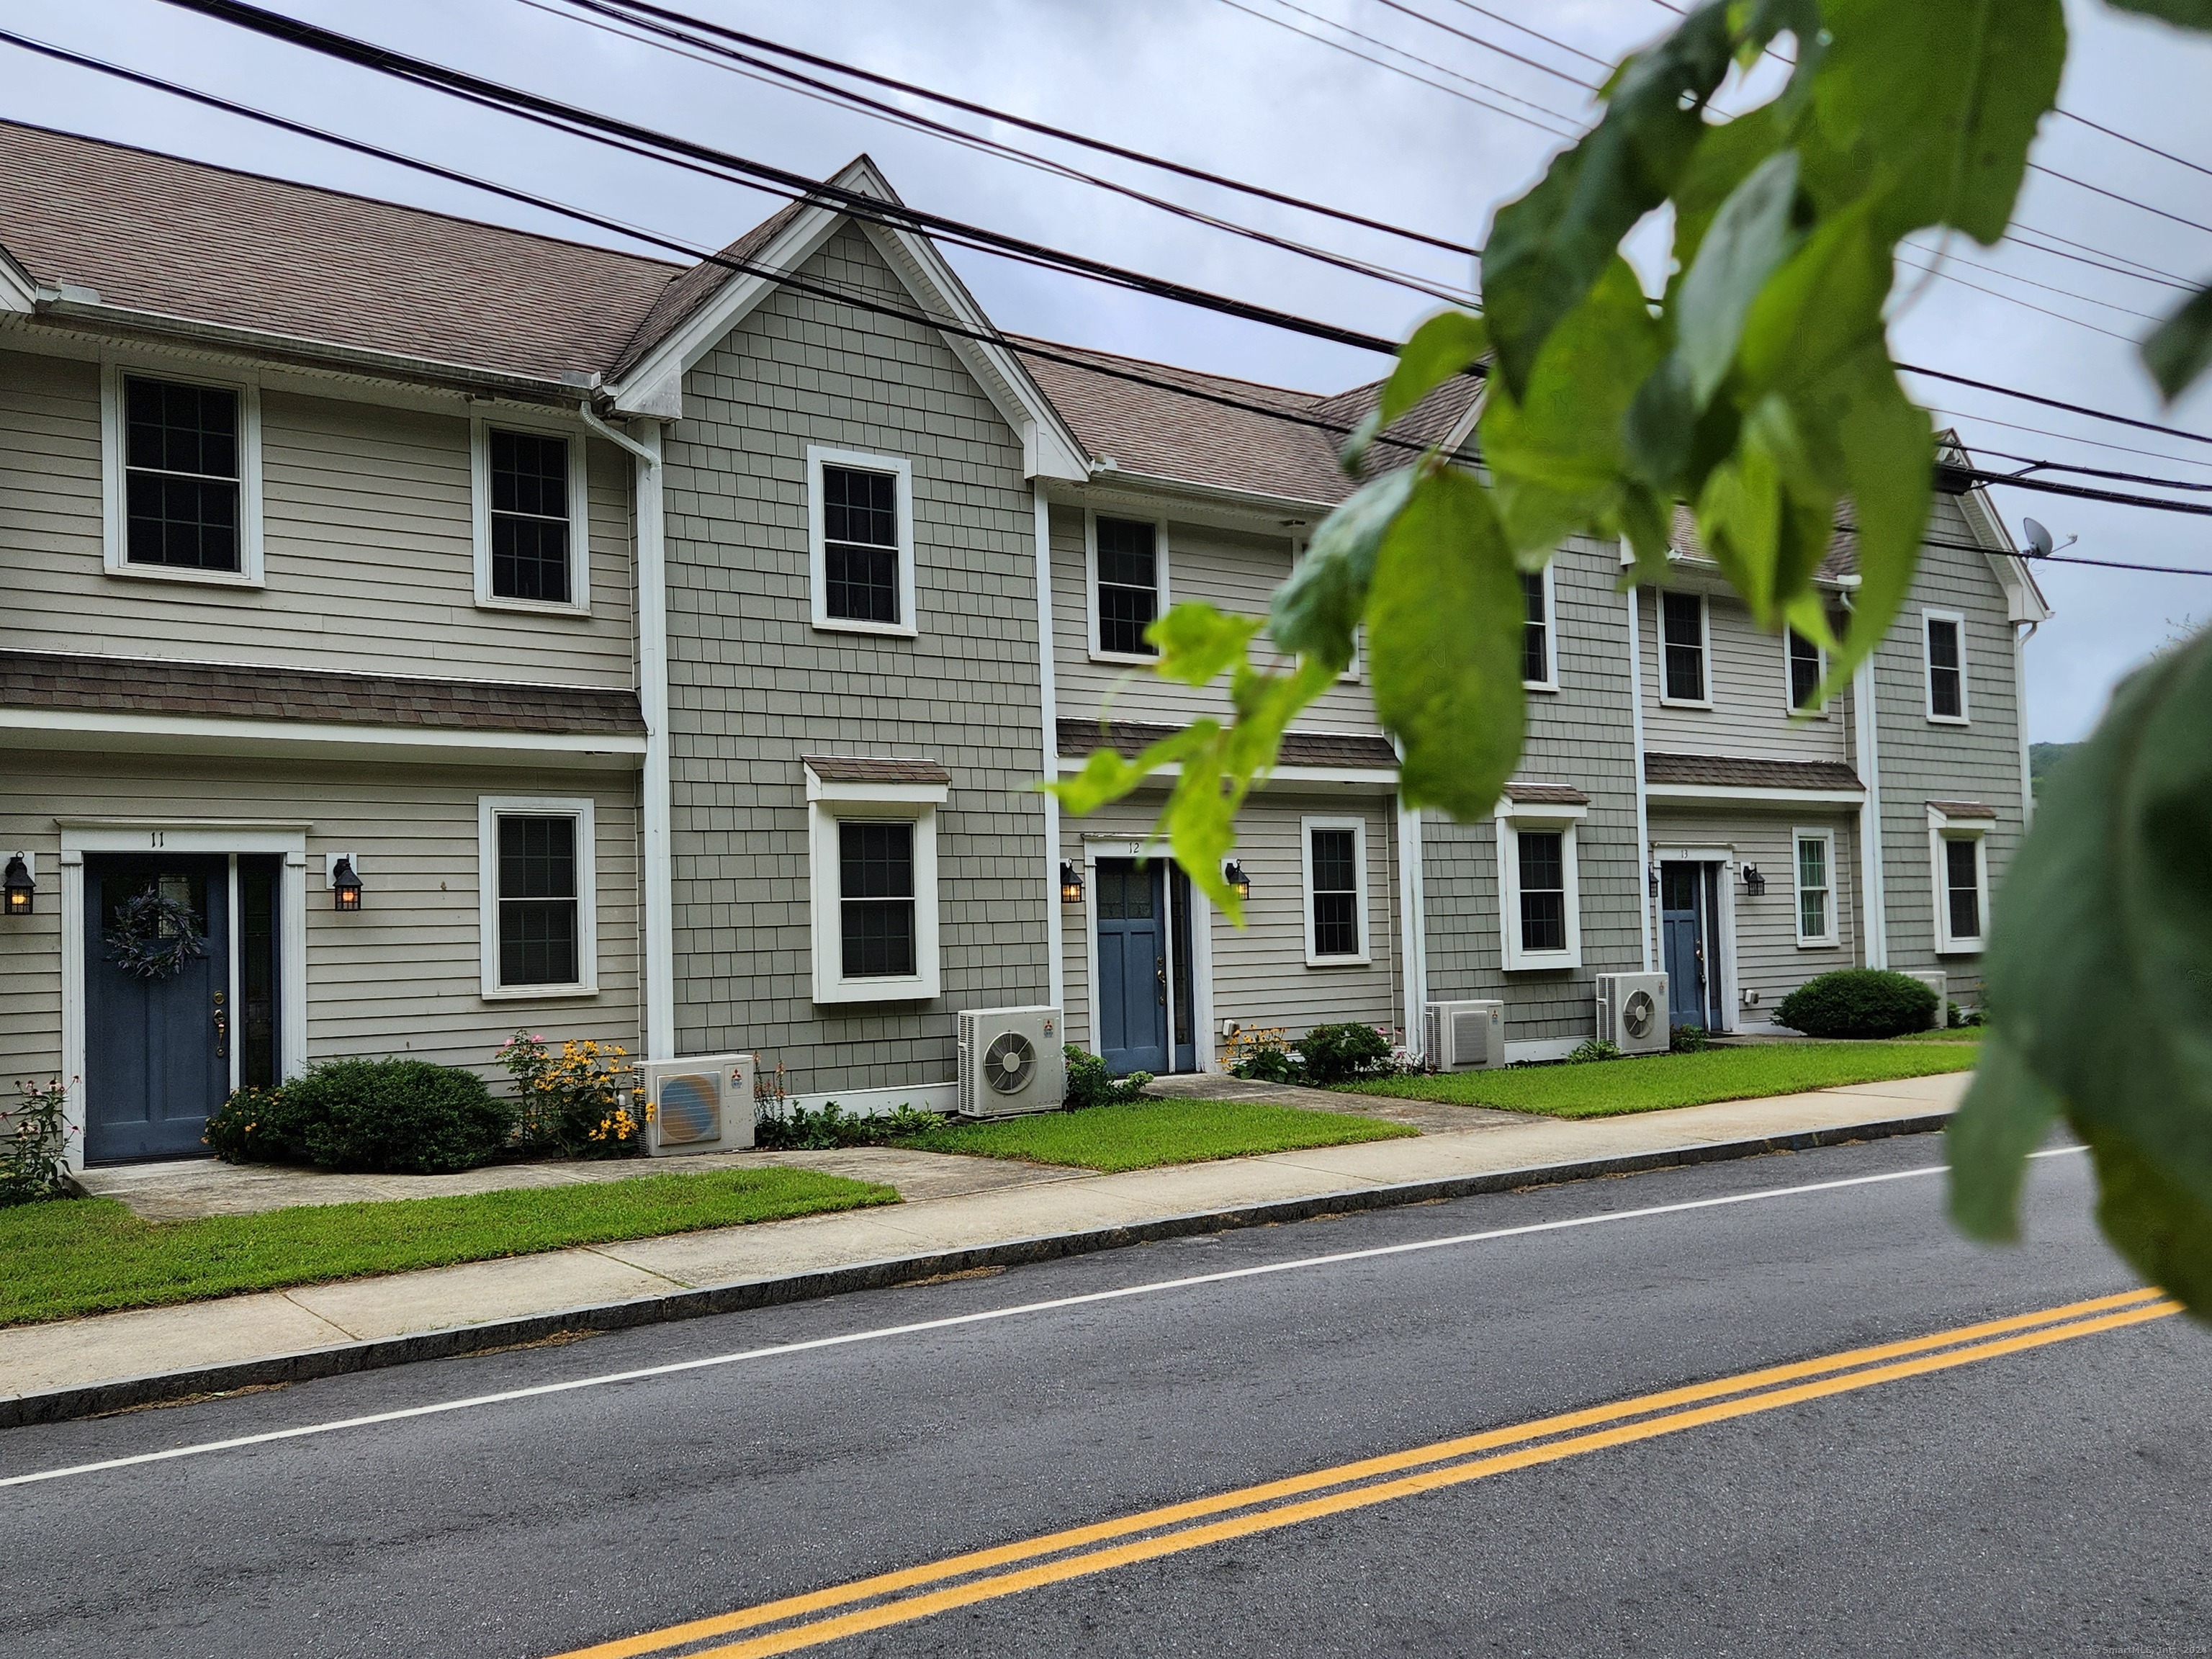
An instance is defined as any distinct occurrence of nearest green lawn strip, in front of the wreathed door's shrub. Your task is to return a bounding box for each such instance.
[0,1168,898,1325]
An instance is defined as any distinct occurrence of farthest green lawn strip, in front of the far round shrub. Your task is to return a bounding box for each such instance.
[1352,1042,1975,1117]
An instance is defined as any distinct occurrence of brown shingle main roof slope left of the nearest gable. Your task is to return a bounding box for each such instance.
[0,122,677,380]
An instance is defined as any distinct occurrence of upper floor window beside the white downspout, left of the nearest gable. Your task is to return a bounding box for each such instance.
[469,421,590,613]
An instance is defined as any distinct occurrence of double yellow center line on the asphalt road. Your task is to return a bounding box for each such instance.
[559,1290,2181,1659]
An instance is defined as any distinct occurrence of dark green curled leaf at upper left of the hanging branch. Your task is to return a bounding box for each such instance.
[1482,0,1734,398]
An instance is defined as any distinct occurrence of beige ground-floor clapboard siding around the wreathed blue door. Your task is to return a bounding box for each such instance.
[0,752,639,1092]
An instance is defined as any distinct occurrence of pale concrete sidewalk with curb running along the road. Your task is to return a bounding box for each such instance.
[0,1073,1969,1426]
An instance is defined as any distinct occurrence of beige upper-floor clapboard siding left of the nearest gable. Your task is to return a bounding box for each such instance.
[0,351,635,685]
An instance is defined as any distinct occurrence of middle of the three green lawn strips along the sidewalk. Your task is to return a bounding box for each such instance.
[900,1100,1418,1170]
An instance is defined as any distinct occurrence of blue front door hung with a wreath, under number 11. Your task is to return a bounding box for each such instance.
[84,854,235,1164]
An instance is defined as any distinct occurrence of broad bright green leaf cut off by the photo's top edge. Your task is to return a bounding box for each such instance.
[1807,0,2066,243]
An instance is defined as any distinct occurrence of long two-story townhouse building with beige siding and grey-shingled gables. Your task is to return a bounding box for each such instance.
[0,124,2041,1159]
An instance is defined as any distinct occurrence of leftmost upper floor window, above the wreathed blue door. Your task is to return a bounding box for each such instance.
[102,363,261,584]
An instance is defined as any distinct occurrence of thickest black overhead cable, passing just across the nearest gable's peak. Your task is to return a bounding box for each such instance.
[151,0,1398,356]
